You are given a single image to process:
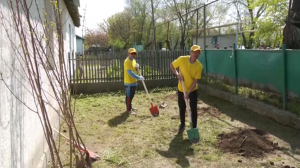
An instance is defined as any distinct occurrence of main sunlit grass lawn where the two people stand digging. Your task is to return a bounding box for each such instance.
[51,88,300,168]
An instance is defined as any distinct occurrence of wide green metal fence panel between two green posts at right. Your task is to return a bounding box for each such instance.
[237,50,283,93]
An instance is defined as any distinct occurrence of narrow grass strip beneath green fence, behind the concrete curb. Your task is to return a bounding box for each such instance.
[201,79,300,116]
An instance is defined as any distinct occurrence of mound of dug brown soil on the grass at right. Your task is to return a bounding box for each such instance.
[218,129,278,158]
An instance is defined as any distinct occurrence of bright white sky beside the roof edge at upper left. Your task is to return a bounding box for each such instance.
[75,0,125,36]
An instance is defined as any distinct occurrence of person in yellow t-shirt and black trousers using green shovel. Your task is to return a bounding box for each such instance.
[170,45,203,134]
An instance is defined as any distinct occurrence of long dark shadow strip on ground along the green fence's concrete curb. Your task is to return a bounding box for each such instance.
[199,93,300,155]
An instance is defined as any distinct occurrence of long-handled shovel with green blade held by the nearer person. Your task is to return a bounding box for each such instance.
[180,78,200,143]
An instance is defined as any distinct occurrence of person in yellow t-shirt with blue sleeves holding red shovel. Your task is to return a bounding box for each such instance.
[124,48,144,114]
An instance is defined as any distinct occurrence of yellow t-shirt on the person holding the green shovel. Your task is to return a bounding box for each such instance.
[172,56,203,92]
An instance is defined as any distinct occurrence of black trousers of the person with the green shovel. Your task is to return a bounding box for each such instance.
[178,90,198,128]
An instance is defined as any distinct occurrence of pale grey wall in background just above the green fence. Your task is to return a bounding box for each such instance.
[193,34,236,49]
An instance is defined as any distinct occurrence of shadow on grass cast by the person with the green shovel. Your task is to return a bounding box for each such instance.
[156,134,194,167]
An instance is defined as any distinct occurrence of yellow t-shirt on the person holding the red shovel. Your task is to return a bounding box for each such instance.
[124,57,137,84]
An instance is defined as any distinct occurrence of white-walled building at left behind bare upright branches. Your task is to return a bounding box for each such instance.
[0,0,80,168]
